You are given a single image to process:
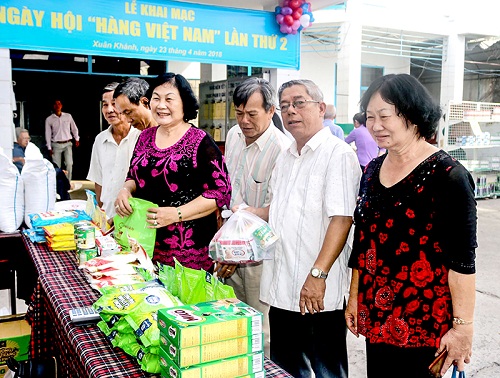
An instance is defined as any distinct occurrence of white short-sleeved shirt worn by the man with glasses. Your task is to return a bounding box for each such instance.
[260,128,361,312]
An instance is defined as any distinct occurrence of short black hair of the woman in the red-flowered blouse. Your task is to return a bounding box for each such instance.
[360,74,441,139]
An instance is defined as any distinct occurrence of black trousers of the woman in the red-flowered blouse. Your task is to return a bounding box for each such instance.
[366,341,437,378]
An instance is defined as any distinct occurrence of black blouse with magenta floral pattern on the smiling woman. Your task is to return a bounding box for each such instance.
[127,126,231,270]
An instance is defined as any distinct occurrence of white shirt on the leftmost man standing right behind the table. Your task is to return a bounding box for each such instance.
[87,126,141,218]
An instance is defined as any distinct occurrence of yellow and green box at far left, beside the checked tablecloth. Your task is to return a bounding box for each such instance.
[0,314,31,365]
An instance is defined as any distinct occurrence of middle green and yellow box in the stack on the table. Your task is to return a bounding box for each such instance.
[160,333,264,367]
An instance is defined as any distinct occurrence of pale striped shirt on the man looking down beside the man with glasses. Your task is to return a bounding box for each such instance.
[225,125,291,207]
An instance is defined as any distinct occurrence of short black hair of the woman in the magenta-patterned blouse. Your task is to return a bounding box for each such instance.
[147,72,200,122]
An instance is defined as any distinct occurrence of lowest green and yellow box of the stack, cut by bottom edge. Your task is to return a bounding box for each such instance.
[160,348,265,378]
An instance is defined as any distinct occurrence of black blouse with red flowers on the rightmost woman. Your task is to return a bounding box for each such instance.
[349,151,476,347]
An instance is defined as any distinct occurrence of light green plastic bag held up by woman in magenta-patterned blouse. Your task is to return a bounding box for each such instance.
[113,197,158,258]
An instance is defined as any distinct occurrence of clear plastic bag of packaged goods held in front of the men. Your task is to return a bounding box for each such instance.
[209,210,278,264]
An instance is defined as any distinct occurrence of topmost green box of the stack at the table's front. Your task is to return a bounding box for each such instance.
[158,299,262,348]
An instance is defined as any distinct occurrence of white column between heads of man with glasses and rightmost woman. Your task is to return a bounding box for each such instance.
[336,0,362,123]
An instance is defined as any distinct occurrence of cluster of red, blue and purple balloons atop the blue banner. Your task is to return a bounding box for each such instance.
[275,0,314,34]
